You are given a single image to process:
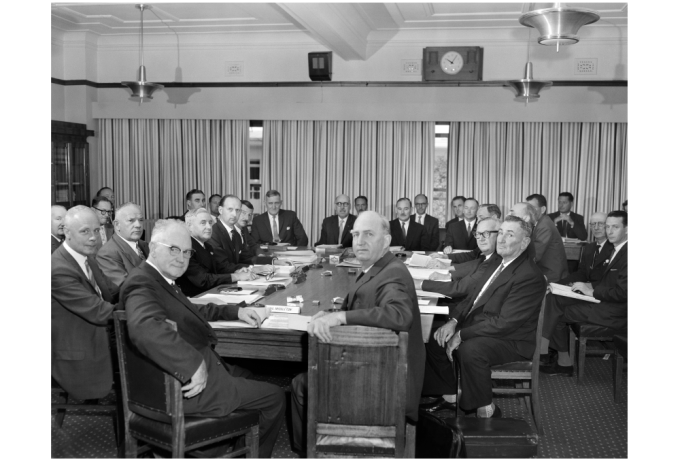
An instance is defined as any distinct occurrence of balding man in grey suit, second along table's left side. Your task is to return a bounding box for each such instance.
[97,203,149,286]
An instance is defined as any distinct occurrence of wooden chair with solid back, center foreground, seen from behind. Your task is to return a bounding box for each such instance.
[307,326,415,458]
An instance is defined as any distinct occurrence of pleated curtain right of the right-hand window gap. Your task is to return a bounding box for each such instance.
[448,122,628,237]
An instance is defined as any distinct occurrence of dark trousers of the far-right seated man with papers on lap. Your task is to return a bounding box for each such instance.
[543,294,597,352]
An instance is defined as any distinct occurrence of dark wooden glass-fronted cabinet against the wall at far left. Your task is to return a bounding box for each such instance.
[51,120,94,208]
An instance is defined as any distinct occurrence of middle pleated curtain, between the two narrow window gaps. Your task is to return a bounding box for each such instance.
[262,121,434,243]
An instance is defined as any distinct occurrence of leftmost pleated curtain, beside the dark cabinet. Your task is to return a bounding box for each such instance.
[98,119,249,219]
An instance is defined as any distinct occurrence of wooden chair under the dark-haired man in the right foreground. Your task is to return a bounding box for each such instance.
[455,296,545,435]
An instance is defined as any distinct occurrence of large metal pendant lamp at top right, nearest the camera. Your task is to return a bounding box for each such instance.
[519,2,600,53]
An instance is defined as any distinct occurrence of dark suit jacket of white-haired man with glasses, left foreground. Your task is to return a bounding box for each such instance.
[120,262,241,417]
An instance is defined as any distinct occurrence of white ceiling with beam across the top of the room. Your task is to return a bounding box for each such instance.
[51,2,628,60]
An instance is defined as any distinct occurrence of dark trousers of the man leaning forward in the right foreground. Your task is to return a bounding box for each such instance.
[456,337,527,410]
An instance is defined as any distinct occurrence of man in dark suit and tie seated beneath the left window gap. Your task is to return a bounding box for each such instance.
[252,190,309,248]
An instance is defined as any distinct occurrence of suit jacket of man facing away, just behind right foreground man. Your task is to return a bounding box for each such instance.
[528,214,569,283]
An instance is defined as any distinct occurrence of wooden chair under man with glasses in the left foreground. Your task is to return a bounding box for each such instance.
[114,311,259,458]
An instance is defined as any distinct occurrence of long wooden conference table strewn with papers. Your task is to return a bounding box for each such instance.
[198,246,440,362]
